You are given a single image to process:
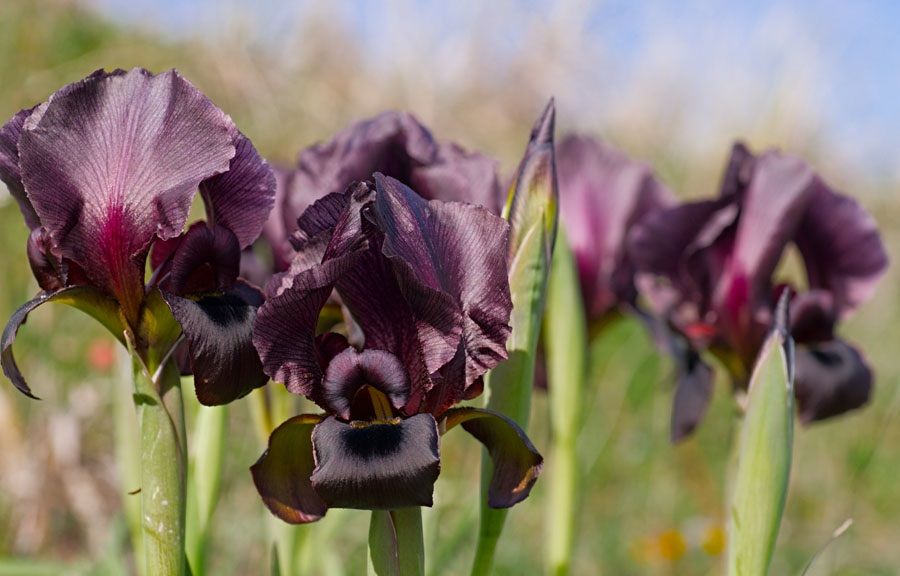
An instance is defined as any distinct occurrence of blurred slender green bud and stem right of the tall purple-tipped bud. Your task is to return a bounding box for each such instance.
[544,227,588,575]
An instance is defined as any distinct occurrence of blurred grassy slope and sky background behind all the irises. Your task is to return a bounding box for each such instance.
[0,0,900,576]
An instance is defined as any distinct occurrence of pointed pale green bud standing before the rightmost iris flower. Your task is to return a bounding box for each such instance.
[728,294,794,576]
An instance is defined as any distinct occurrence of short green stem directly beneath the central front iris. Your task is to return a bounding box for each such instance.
[369,508,425,576]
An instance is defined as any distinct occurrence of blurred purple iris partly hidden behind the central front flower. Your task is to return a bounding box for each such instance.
[244,111,503,278]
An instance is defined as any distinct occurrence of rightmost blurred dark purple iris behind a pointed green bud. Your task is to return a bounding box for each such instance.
[629,144,888,440]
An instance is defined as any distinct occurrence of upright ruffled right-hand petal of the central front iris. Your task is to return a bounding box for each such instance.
[374,174,512,386]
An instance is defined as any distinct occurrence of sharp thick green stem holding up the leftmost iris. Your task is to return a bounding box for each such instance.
[134,361,187,576]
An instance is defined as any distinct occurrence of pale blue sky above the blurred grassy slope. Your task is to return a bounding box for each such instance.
[91,0,900,176]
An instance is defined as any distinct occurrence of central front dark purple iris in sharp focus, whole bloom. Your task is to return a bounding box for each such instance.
[252,173,543,523]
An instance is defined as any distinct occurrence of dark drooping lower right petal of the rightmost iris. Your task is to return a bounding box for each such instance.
[794,339,873,424]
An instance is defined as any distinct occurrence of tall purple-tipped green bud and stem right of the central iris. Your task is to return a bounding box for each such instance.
[472,101,558,576]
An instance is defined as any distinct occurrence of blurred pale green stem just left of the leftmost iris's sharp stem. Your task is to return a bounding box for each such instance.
[113,349,145,576]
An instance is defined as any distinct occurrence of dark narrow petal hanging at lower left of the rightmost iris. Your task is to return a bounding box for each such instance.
[670,350,714,442]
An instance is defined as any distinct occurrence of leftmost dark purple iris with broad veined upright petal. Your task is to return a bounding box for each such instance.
[0,69,275,404]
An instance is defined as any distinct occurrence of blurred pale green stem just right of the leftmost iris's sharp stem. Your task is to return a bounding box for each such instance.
[184,379,228,576]
